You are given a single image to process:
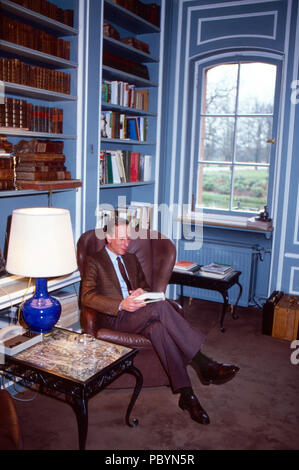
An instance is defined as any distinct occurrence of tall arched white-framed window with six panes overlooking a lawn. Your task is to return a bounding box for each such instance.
[196,61,277,213]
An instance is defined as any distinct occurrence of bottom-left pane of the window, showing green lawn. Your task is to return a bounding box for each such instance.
[197,164,231,209]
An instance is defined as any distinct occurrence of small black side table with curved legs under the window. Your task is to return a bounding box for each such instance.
[169,271,242,333]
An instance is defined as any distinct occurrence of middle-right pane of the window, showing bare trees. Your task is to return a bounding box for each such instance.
[236,117,272,163]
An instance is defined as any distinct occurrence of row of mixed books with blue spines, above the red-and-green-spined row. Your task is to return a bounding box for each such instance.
[101,111,147,142]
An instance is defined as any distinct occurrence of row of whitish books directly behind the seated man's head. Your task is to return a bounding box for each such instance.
[97,201,153,230]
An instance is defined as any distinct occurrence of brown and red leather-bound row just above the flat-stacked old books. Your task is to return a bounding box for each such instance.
[0,98,63,134]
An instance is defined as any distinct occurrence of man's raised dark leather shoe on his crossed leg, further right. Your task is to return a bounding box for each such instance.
[193,361,240,385]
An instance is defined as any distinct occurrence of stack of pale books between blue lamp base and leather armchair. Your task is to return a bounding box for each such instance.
[51,290,80,328]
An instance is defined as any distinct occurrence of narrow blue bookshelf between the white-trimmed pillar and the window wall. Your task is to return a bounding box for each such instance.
[98,0,164,228]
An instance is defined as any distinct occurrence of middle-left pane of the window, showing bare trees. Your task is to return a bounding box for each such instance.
[200,117,235,162]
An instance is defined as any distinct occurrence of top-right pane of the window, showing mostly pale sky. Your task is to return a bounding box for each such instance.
[238,62,276,114]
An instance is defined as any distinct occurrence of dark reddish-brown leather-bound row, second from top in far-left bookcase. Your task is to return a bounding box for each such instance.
[0,15,70,60]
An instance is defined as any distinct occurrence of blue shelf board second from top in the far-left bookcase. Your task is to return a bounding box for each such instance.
[0,39,78,69]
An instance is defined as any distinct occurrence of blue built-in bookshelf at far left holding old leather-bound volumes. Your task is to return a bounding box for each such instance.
[0,0,83,258]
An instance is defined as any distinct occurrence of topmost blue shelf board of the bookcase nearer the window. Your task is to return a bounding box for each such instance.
[104,0,160,34]
